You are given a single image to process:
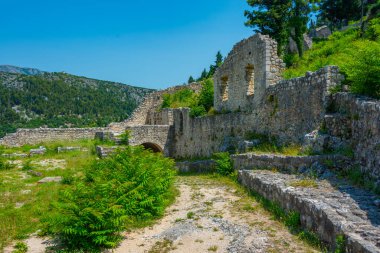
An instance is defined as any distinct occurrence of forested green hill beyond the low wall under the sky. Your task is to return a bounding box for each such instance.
[0,72,153,137]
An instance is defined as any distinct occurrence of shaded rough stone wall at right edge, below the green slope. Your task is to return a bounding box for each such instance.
[325,93,380,181]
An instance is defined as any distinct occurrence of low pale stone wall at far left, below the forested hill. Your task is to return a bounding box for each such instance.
[0,128,106,147]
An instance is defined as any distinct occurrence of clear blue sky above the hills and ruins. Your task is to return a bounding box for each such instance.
[0,0,252,89]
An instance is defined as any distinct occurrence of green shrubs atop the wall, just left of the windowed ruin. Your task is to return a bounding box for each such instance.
[161,78,214,117]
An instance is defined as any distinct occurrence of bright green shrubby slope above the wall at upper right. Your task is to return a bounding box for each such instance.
[284,18,380,98]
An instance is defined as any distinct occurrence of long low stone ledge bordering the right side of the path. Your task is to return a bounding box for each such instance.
[238,170,380,253]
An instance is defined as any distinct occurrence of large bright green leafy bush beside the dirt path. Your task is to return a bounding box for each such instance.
[44,147,175,251]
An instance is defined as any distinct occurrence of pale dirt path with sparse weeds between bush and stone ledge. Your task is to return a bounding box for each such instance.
[114,176,316,253]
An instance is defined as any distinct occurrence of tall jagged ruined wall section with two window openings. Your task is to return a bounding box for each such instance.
[214,34,285,111]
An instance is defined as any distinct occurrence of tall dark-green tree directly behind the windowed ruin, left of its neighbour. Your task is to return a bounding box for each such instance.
[244,0,292,54]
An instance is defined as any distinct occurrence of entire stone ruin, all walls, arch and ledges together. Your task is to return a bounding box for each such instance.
[0,34,380,252]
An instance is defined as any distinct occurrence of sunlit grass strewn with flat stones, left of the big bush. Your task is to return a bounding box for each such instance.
[0,140,96,250]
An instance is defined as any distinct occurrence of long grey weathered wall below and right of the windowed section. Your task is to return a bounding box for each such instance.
[173,66,341,157]
